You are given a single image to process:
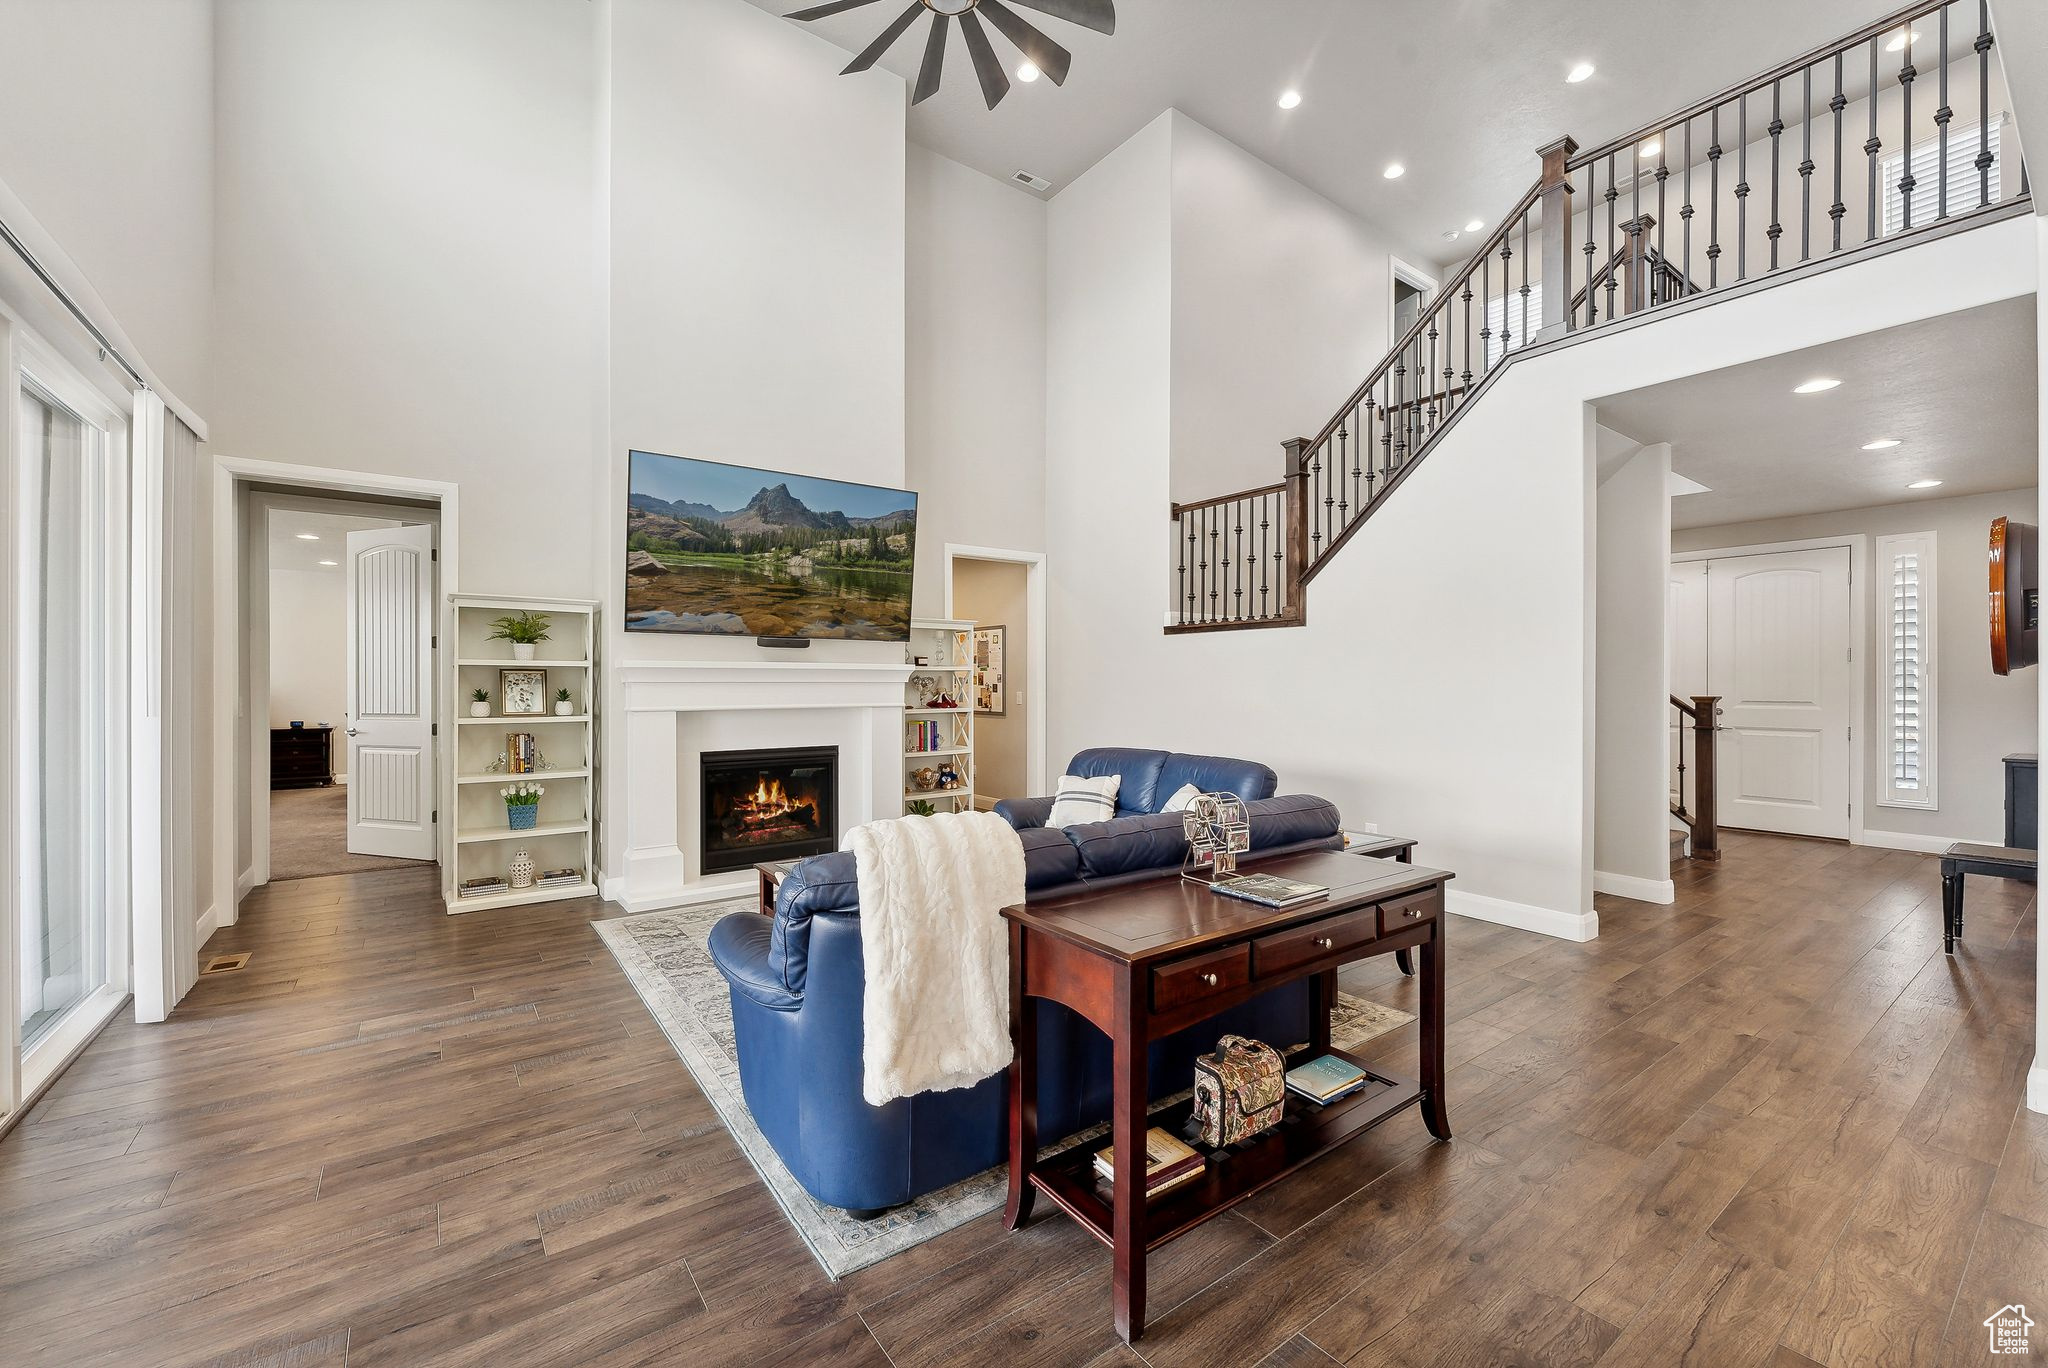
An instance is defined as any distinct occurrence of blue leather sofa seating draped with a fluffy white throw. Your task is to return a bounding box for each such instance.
[711,750,1337,1216]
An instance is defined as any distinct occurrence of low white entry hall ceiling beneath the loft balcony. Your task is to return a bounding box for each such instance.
[1597,295,2038,528]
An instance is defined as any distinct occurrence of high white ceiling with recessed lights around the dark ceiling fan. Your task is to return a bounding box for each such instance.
[754,0,1894,262]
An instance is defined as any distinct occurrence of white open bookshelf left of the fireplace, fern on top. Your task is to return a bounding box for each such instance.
[440,594,600,913]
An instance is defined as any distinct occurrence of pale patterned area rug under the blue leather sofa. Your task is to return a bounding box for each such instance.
[594,897,1413,1278]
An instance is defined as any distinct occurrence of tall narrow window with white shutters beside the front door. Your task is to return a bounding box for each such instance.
[1876,532,1935,807]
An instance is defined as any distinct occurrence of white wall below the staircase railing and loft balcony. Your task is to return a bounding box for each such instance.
[1049,194,2036,936]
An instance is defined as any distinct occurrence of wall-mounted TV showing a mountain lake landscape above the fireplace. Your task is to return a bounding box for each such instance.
[627,451,918,641]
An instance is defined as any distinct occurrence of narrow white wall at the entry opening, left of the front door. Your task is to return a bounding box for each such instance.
[1593,442,1673,903]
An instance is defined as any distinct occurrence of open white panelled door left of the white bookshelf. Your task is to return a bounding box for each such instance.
[348,526,434,860]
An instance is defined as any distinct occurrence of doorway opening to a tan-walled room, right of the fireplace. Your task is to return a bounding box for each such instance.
[946,545,1047,811]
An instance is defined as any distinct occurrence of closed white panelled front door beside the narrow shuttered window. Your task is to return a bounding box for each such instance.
[1706,547,1855,838]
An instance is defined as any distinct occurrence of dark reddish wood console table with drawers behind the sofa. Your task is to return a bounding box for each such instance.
[1004,852,1450,1339]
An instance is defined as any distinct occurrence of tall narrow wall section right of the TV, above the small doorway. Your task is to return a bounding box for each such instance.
[903,145,1047,616]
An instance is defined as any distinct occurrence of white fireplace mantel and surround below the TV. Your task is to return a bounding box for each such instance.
[604,659,911,911]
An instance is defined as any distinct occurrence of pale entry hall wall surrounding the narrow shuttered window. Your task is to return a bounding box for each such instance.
[1671,489,2038,848]
